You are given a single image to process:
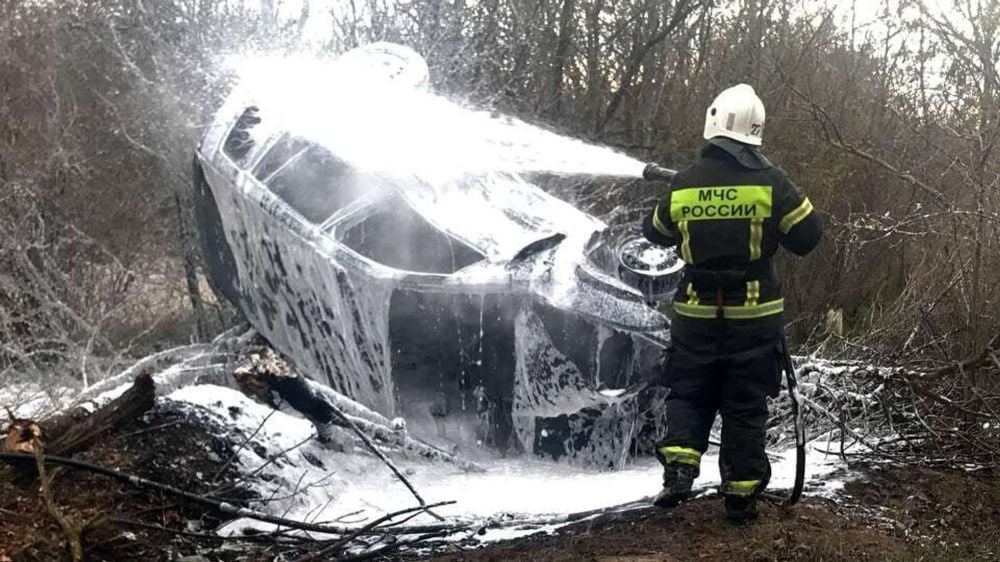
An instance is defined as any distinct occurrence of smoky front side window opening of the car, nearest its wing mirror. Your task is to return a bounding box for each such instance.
[338,197,484,274]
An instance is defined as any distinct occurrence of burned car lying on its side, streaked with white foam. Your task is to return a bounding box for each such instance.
[194,42,684,467]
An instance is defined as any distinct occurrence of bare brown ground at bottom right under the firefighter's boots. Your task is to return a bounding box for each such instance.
[436,467,1000,562]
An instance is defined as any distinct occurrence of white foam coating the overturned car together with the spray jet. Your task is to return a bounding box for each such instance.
[196,44,667,466]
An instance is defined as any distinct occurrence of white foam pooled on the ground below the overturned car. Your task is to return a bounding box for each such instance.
[169,385,846,541]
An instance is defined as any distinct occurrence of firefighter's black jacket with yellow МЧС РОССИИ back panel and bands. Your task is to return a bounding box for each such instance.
[643,138,822,323]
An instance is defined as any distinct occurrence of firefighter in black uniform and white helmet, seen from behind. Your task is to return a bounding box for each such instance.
[643,84,822,522]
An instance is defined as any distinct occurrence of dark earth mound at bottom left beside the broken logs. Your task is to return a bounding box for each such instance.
[0,401,270,562]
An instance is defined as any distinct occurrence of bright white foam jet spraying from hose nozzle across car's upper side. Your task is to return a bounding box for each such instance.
[223,43,643,182]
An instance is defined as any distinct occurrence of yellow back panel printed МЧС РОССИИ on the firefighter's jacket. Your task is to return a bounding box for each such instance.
[670,185,772,223]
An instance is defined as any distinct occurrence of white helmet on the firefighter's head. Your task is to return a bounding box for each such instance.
[705,84,764,146]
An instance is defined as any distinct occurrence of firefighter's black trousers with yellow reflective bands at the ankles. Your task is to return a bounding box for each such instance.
[657,315,783,497]
